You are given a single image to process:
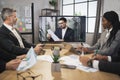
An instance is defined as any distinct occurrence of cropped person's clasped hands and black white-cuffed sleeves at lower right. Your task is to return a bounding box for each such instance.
[80,54,120,75]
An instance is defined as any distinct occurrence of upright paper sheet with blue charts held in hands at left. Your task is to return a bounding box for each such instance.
[17,47,37,71]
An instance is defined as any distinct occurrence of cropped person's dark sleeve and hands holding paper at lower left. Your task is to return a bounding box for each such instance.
[0,48,25,73]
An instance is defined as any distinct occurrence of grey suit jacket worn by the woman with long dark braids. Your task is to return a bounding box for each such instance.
[89,30,120,56]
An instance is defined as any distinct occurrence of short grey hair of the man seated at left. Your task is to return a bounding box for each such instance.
[1,8,16,21]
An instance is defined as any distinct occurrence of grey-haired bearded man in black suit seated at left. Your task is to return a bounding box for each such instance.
[0,8,42,56]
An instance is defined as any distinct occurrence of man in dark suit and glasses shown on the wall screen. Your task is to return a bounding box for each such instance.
[47,17,74,42]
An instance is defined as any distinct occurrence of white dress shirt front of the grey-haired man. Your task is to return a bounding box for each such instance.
[3,23,25,48]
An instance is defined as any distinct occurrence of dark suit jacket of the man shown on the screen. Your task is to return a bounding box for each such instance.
[55,27,74,42]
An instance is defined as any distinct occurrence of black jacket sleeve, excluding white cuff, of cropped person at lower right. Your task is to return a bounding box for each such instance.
[99,56,120,75]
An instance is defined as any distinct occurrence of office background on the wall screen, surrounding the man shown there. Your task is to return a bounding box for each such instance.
[39,16,86,42]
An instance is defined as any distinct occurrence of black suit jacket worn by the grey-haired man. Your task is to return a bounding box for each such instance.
[0,25,34,55]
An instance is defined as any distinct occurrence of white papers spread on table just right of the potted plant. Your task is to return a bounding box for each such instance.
[60,55,98,72]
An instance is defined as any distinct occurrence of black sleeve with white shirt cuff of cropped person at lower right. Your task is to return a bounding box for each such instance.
[93,56,120,75]
